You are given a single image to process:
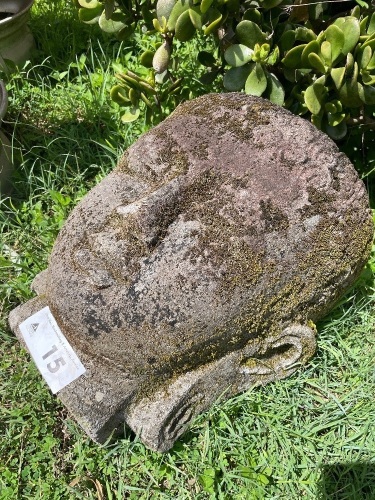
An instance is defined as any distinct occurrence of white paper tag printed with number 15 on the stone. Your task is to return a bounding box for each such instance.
[20,306,86,394]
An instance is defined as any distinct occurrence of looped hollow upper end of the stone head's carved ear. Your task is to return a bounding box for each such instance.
[241,325,316,385]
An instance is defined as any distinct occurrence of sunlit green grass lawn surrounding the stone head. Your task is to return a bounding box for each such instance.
[0,0,375,500]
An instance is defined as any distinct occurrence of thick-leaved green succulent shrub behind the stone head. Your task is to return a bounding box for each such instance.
[76,0,375,165]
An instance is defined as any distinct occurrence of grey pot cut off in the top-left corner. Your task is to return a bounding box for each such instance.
[0,0,34,68]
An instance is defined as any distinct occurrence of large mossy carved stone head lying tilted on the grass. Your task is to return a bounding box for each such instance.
[10,93,373,451]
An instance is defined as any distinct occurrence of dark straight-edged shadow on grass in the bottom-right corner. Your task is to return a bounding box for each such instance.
[317,462,375,500]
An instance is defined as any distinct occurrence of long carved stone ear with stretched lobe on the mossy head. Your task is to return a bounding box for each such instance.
[125,325,316,451]
